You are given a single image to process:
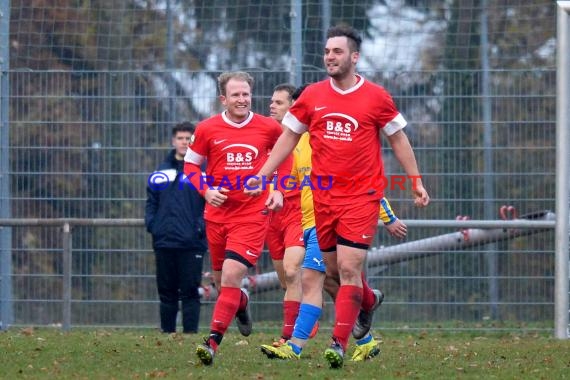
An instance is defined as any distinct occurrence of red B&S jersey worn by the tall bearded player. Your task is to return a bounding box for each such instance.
[282,76,406,204]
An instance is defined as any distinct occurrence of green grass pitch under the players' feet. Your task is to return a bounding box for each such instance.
[0,328,570,380]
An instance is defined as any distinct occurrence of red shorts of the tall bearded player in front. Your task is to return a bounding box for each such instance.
[314,199,380,252]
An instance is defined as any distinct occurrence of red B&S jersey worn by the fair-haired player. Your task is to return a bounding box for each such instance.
[184,112,282,223]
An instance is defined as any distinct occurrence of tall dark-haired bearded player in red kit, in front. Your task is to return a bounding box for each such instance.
[246,26,429,368]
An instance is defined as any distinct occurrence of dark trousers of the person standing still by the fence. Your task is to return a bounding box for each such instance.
[155,249,204,333]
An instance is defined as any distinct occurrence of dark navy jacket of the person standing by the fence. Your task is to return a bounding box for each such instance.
[145,149,207,252]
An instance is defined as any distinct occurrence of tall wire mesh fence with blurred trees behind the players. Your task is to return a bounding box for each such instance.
[0,0,556,332]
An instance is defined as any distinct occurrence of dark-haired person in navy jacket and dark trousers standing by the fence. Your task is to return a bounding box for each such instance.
[145,122,206,333]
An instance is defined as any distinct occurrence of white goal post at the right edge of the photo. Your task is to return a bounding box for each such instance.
[554,1,570,339]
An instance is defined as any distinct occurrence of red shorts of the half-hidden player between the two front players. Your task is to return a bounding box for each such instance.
[265,194,305,260]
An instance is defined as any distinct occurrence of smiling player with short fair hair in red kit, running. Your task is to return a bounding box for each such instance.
[184,72,283,365]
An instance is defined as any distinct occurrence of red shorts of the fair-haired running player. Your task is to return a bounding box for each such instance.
[206,215,269,271]
